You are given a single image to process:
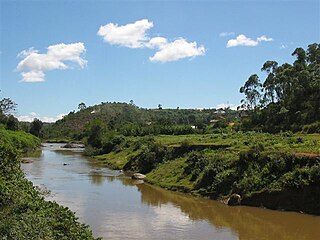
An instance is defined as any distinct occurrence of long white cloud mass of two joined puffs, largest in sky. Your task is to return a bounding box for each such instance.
[97,19,205,62]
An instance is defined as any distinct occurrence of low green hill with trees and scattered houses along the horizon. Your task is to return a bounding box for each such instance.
[43,103,237,140]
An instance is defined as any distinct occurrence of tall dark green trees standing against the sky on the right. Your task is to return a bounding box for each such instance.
[240,43,320,132]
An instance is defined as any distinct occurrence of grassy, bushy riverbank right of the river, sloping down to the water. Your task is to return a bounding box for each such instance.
[95,132,320,215]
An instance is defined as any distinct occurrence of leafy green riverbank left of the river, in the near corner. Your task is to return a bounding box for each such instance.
[0,129,99,239]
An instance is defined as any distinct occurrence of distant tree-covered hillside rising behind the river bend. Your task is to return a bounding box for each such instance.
[43,103,237,140]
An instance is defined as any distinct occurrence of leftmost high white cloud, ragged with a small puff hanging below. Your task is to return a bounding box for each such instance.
[17,42,87,82]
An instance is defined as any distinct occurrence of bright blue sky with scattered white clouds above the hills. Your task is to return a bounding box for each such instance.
[0,0,320,121]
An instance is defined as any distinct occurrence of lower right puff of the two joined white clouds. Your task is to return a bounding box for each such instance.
[149,38,206,62]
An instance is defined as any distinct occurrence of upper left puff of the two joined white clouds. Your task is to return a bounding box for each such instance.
[97,19,153,48]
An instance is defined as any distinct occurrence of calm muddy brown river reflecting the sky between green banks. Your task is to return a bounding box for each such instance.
[22,144,320,240]
